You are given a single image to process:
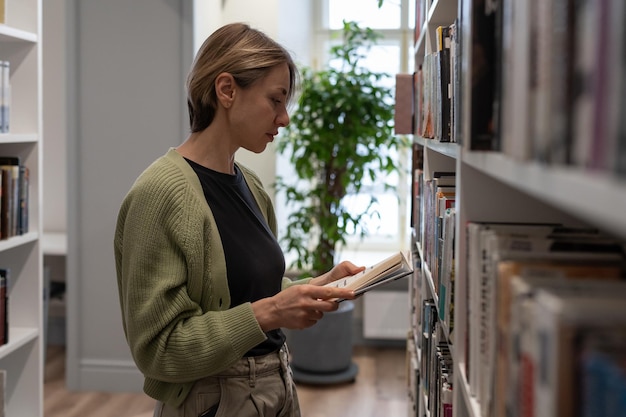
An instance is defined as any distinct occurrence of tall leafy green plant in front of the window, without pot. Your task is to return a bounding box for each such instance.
[275,22,406,274]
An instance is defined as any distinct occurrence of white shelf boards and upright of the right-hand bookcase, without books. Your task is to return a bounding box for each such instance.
[410,0,626,417]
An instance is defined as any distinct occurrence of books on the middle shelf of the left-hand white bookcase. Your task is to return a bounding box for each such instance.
[0,156,30,239]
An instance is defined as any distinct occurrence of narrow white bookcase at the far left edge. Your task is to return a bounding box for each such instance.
[0,0,43,416]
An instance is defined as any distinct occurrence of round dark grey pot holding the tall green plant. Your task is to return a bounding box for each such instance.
[285,301,358,384]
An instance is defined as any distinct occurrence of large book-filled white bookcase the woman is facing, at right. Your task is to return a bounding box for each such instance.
[407,0,626,417]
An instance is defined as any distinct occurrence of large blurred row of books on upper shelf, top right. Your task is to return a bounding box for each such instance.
[469,0,626,174]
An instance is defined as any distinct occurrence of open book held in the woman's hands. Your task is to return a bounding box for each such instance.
[325,252,413,301]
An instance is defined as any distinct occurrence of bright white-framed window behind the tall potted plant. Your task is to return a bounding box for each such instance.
[277,0,415,264]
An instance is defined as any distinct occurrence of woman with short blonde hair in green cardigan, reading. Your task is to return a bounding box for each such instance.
[115,23,363,417]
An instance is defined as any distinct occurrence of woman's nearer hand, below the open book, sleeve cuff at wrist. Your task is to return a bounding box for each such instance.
[252,282,360,332]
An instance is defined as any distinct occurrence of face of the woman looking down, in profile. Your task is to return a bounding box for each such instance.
[229,64,290,153]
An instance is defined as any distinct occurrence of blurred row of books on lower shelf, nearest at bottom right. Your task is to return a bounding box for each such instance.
[462,222,626,417]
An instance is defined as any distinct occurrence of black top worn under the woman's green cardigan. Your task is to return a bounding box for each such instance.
[187,160,285,356]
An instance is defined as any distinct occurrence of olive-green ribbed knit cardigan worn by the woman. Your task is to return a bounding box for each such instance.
[114,149,308,407]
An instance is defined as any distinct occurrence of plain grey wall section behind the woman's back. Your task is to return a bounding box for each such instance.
[64,0,193,391]
